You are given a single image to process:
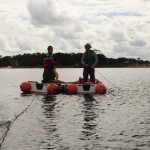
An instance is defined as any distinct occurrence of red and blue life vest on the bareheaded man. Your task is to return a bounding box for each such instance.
[43,53,54,68]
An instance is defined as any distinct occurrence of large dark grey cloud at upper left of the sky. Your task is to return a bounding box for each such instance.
[28,0,71,26]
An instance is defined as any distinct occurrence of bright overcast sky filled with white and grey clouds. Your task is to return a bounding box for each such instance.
[0,0,150,61]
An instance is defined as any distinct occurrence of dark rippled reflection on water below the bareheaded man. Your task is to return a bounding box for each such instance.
[42,95,59,149]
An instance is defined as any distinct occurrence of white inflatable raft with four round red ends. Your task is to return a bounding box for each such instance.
[20,79,106,94]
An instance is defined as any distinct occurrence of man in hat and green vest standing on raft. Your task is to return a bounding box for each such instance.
[81,43,98,83]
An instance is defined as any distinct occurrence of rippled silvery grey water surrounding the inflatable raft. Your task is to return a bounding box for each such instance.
[0,68,150,150]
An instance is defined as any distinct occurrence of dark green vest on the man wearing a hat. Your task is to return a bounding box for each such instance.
[83,50,95,66]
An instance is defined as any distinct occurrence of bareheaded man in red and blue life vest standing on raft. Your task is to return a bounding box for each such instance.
[42,46,58,83]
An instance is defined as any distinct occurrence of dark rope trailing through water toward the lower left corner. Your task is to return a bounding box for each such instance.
[0,95,36,147]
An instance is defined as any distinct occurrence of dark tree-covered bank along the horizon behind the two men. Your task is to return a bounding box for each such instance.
[0,53,150,68]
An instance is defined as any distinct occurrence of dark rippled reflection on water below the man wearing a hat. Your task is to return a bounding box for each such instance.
[80,94,99,150]
